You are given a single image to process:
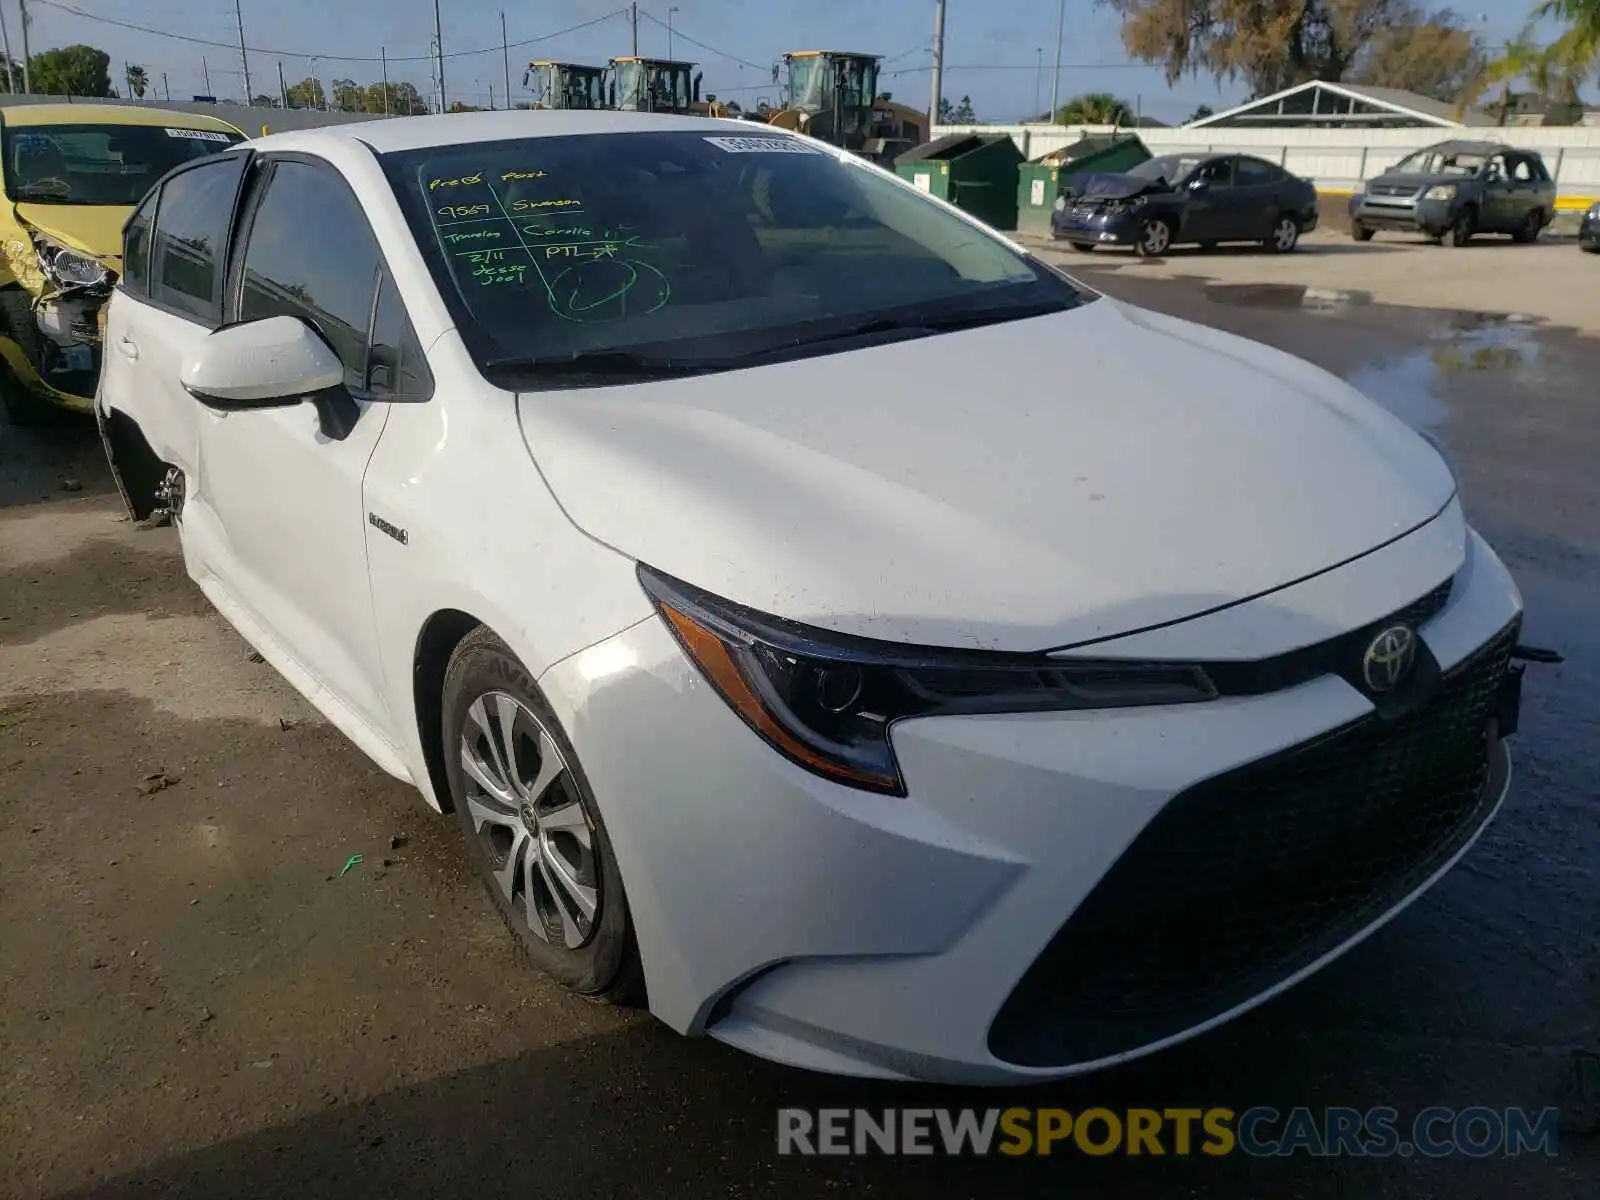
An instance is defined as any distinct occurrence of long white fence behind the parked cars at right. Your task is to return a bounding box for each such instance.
[933,125,1600,208]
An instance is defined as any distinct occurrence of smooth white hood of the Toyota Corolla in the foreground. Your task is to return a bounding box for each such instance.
[518,298,1454,650]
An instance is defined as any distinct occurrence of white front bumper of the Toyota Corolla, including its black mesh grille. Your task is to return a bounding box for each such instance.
[541,520,1520,1083]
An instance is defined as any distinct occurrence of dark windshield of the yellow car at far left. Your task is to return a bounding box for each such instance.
[3,125,243,205]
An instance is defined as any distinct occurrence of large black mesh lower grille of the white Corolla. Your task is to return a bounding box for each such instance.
[989,622,1520,1066]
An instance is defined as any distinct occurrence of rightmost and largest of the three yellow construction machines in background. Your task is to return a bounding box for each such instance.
[765,50,928,166]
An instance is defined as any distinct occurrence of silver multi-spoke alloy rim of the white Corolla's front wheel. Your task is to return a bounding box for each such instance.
[459,691,603,950]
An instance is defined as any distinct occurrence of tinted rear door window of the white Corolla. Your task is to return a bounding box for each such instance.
[150,154,245,325]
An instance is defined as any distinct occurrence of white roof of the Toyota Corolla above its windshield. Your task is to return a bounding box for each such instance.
[251,109,795,154]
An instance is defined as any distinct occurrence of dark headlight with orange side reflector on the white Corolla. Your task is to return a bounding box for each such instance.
[638,563,1218,795]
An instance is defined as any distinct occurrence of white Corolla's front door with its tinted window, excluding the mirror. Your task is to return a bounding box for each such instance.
[200,158,394,739]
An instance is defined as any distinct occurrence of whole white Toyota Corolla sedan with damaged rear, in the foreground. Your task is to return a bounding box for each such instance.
[98,112,1522,1082]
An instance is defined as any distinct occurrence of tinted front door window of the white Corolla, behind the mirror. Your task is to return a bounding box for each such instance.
[238,160,382,390]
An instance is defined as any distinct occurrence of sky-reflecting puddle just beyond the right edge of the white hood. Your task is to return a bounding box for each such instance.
[1346,321,1539,429]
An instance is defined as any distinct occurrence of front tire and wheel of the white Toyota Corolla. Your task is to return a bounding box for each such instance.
[440,627,645,1005]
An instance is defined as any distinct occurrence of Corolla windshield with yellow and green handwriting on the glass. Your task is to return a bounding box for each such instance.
[384,125,1090,385]
